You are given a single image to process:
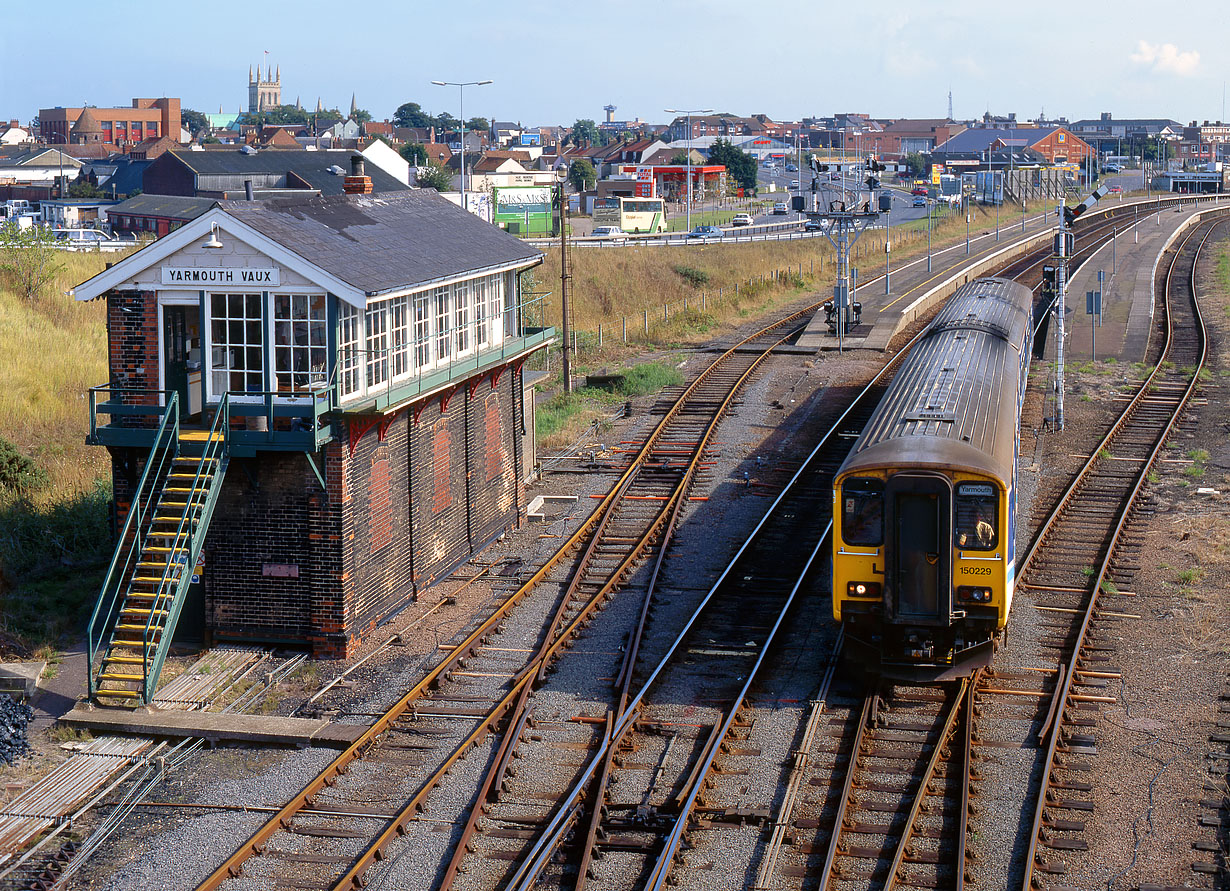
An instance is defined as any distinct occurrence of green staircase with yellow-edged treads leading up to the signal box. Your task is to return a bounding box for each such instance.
[89,393,230,705]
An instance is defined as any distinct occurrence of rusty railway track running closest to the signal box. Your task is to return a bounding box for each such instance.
[200,301,831,889]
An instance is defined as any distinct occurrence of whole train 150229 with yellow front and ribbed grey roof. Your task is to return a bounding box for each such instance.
[833,278,1033,681]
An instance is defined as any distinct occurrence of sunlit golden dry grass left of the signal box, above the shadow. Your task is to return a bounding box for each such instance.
[0,252,118,506]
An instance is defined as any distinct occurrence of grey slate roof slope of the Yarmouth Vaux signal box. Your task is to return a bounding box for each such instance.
[219,190,542,297]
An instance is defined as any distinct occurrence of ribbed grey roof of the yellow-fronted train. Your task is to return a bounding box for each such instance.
[838,278,1032,480]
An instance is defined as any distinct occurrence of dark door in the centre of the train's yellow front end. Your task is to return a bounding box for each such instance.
[889,475,952,624]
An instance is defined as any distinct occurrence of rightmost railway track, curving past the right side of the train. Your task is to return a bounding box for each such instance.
[1008,214,1223,891]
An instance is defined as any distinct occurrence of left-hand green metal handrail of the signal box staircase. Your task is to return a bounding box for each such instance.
[86,386,180,699]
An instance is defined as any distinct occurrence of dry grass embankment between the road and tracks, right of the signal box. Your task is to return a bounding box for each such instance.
[535,195,1062,449]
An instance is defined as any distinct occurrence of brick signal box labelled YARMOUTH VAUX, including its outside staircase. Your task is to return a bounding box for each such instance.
[75,162,554,701]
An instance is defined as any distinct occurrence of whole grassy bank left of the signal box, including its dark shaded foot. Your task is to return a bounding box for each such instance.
[0,254,116,650]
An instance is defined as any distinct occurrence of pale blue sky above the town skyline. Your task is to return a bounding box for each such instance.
[0,0,1230,124]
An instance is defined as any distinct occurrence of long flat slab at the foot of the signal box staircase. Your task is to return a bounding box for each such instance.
[60,704,367,748]
